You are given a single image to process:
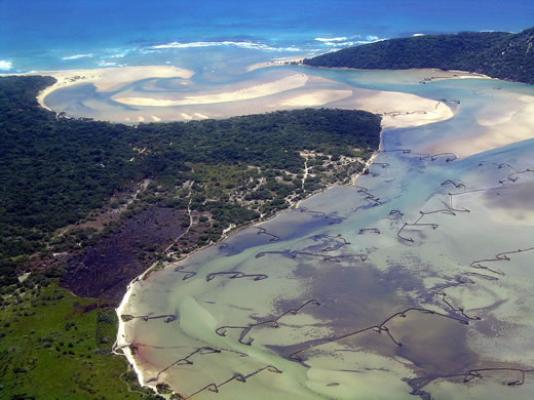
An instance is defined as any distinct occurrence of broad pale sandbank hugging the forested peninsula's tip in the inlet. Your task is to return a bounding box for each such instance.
[113,68,454,129]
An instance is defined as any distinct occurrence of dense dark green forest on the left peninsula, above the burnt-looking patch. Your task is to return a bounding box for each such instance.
[0,77,380,283]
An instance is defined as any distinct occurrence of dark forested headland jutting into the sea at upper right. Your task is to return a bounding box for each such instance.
[304,28,534,83]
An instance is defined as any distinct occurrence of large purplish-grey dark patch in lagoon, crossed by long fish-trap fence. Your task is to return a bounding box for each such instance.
[273,263,477,376]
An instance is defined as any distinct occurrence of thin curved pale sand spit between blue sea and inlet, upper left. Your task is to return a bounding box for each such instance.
[30,65,194,110]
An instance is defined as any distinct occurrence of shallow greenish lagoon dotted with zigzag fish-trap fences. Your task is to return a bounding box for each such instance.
[114,66,534,400]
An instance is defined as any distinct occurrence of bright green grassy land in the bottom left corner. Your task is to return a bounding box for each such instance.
[0,283,158,400]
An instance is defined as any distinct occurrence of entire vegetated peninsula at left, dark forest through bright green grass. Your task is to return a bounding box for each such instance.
[0,76,380,399]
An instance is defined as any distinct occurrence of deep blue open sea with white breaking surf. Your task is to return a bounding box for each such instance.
[0,0,534,72]
